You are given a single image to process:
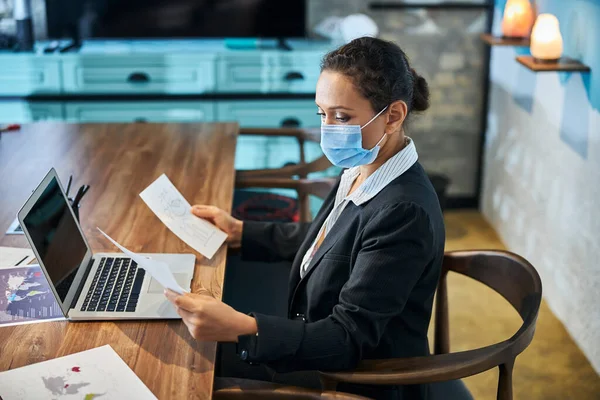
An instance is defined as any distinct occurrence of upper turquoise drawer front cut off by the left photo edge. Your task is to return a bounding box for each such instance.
[0,54,61,96]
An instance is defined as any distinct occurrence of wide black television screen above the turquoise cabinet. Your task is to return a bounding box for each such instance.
[46,0,306,39]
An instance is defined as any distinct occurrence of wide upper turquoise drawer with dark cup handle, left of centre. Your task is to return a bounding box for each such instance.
[63,54,215,94]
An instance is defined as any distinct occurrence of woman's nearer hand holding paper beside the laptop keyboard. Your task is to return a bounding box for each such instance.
[165,289,258,342]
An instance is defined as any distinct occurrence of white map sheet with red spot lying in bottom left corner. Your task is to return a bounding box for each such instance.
[0,345,156,400]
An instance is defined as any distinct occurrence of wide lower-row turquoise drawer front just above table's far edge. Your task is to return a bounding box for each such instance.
[65,101,214,122]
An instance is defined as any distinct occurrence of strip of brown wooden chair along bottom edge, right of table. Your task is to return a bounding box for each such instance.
[213,378,369,400]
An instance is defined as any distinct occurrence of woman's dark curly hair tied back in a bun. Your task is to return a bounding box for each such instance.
[321,37,429,114]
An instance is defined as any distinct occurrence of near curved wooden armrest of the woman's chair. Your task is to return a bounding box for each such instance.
[320,341,516,389]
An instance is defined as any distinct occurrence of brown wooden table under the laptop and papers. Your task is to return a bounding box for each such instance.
[0,123,238,399]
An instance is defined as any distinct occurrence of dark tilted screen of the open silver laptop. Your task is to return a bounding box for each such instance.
[23,178,87,302]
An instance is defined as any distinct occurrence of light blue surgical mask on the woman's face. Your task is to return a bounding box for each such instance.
[321,106,387,168]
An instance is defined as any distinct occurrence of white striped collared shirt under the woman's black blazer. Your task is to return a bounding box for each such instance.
[300,137,419,278]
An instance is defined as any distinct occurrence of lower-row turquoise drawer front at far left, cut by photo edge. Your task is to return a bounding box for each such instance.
[0,101,63,124]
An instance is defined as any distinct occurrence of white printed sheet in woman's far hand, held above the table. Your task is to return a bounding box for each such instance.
[140,174,227,259]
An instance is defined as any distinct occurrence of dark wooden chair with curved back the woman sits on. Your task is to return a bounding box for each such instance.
[321,250,542,400]
